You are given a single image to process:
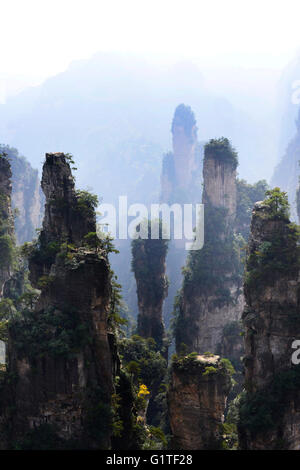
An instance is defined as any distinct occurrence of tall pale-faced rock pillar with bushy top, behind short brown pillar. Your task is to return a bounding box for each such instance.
[176,139,244,360]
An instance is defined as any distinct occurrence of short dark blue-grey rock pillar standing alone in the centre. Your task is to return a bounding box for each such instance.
[132,229,168,349]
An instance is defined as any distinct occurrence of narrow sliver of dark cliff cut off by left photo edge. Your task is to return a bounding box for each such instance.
[0,156,14,296]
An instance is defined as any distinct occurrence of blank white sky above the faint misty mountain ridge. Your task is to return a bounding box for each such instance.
[0,0,300,96]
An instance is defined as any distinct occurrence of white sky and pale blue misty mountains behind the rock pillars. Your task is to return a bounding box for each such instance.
[0,0,300,324]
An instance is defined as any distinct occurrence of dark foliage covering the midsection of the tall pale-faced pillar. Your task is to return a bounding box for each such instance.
[172,204,244,349]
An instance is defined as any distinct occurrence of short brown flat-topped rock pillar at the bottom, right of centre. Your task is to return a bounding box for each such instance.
[168,355,231,450]
